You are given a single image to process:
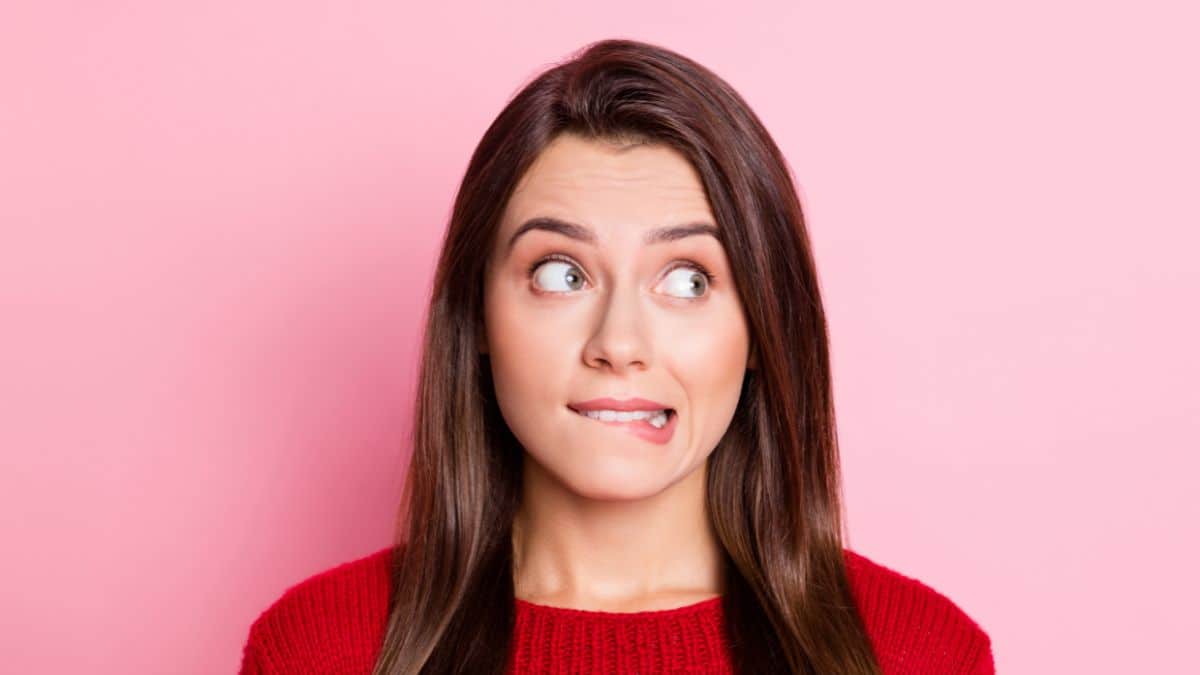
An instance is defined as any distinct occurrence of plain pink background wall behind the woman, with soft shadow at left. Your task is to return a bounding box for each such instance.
[0,0,1200,674]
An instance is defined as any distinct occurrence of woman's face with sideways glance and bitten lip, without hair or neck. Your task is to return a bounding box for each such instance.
[480,135,752,500]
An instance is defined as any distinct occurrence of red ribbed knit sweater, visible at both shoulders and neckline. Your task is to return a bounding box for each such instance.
[241,546,995,675]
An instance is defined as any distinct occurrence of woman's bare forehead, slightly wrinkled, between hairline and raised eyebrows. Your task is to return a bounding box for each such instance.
[502,133,713,232]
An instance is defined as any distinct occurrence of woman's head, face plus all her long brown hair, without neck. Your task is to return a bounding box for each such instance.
[376,40,877,674]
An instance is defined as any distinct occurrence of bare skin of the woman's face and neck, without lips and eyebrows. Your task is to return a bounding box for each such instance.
[480,135,754,611]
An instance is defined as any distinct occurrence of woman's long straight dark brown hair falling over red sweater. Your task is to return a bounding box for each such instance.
[374,40,880,675]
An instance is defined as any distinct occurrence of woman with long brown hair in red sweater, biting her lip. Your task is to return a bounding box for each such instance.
[242,40,994,675]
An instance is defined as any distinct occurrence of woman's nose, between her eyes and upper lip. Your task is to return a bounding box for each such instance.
[583,279,652,374]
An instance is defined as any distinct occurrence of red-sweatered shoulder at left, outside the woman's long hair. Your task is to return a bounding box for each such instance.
[241,546,394,674]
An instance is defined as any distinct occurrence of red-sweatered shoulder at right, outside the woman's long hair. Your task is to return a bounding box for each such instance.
[844,549,995,675]
